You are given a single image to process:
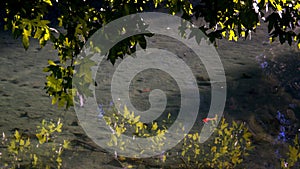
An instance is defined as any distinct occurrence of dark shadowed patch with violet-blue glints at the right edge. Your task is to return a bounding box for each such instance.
[219,45,300,168]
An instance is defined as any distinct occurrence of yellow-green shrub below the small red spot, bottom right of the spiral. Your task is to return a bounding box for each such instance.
[181,118,253,169]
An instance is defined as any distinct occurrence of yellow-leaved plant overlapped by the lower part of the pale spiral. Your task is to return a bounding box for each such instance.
[103,103,170,154]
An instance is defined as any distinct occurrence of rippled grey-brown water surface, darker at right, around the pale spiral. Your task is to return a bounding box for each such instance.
[0,19,300,169]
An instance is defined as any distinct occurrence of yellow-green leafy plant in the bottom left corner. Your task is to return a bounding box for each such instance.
[0,119,70,169]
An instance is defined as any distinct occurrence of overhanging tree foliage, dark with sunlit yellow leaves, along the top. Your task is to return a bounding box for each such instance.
[0,0,300,107]
